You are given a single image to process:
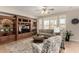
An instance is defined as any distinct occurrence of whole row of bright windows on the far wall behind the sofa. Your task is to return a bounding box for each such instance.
[38,15,66,29]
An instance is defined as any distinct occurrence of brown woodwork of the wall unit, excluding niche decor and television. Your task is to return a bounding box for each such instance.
[0,15,36,44]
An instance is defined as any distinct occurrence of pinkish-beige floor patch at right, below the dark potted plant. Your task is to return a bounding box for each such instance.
[64,41,79,53]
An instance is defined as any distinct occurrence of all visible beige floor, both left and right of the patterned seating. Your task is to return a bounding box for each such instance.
[0,37,79,53]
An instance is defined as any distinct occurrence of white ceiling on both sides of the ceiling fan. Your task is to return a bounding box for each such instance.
[0,6,79,17]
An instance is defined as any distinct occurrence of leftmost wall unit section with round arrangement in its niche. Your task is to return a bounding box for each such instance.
[0,15,15,44]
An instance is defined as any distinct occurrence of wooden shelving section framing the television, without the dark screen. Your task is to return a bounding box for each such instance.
[16,16,32,40]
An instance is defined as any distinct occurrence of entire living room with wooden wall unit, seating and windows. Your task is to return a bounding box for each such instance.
[0,6,79,53]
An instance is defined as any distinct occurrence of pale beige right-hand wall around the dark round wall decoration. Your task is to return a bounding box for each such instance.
[66,10,79,41]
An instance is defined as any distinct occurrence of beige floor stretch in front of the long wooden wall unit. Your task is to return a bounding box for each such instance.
[0,37,33,53]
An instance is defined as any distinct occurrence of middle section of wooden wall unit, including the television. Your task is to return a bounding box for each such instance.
[17,16,32,40]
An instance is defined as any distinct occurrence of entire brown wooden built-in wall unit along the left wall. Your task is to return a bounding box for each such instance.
[0,15,37,44]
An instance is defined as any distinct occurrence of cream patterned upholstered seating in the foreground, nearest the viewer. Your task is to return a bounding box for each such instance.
[32,36,62,53]
